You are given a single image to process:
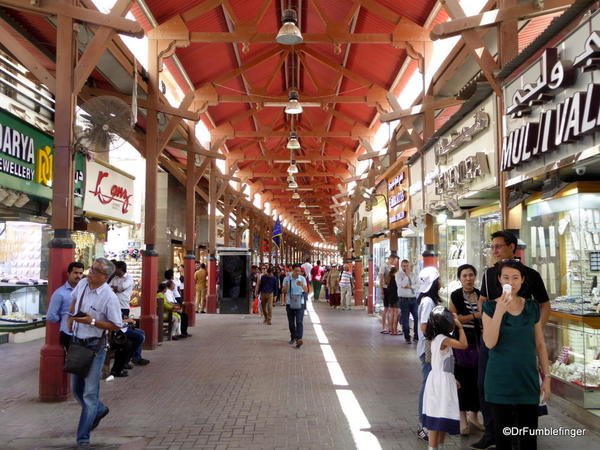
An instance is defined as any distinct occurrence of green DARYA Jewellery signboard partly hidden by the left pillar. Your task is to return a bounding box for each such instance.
[0,109,84,206]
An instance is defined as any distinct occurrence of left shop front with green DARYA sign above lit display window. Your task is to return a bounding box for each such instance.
[0,110,83,333]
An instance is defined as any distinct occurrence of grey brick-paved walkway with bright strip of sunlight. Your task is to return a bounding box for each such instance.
[0,303,600,450]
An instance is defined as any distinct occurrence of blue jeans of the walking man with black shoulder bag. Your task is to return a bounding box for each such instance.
[71,341,108,444]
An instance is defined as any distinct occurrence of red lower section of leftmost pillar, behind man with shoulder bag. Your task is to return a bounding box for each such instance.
[40,241,75,402]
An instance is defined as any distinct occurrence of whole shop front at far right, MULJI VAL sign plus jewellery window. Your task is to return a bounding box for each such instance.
[501,13,600,409]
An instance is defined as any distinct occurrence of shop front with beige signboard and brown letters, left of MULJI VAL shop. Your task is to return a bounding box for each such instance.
[423,96,501,297]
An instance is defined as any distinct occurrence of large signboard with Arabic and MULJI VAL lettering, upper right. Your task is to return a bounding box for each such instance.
[501,14,600,185]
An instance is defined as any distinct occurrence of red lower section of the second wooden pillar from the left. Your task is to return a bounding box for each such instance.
[140,250,158,350]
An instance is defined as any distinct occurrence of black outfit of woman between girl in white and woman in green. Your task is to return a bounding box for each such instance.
[450,288,481,412]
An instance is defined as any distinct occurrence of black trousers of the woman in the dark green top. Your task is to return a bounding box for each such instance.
[488,403,538,450]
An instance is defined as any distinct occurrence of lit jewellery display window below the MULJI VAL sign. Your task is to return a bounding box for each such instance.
[522,193,600,400]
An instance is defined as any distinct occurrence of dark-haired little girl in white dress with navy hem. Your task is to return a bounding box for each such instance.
[421,306,468,450]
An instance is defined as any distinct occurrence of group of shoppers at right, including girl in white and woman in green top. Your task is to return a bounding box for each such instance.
[410,231,550,450]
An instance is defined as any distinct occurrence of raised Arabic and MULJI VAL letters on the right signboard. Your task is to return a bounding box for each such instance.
[501,29,600,171]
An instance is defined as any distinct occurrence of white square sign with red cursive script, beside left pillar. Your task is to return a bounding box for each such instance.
[83,161,135,223]
